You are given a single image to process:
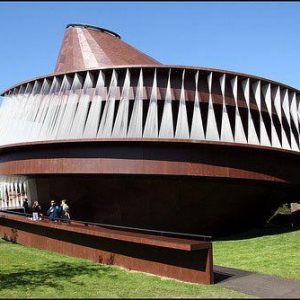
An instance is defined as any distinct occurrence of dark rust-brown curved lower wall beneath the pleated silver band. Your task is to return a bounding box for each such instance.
[0,139,300,237]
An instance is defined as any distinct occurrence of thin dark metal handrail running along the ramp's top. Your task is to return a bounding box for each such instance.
[0,209,212,241]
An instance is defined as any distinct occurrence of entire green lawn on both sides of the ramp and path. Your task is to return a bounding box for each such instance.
[0,226,300,298]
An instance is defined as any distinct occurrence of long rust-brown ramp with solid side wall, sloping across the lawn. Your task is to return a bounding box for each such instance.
[0,211,214,284]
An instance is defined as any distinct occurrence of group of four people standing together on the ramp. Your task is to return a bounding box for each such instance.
[23,198,70,221]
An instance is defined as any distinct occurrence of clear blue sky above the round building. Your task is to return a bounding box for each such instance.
[0,2,300,96]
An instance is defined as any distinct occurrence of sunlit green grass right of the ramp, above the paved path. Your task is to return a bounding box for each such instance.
[213,226,300,280]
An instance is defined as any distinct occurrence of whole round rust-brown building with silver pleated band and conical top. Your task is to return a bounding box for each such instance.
[0,24,300,236]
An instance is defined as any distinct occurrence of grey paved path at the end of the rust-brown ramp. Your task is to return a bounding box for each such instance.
[214,266,300,299]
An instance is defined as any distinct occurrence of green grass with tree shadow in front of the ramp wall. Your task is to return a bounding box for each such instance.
[0,239,250,298]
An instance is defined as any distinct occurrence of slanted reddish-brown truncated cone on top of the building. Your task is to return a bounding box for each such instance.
[54,24,160,73]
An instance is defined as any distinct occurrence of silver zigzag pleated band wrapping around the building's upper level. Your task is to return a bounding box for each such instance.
[0,67,300,152]
